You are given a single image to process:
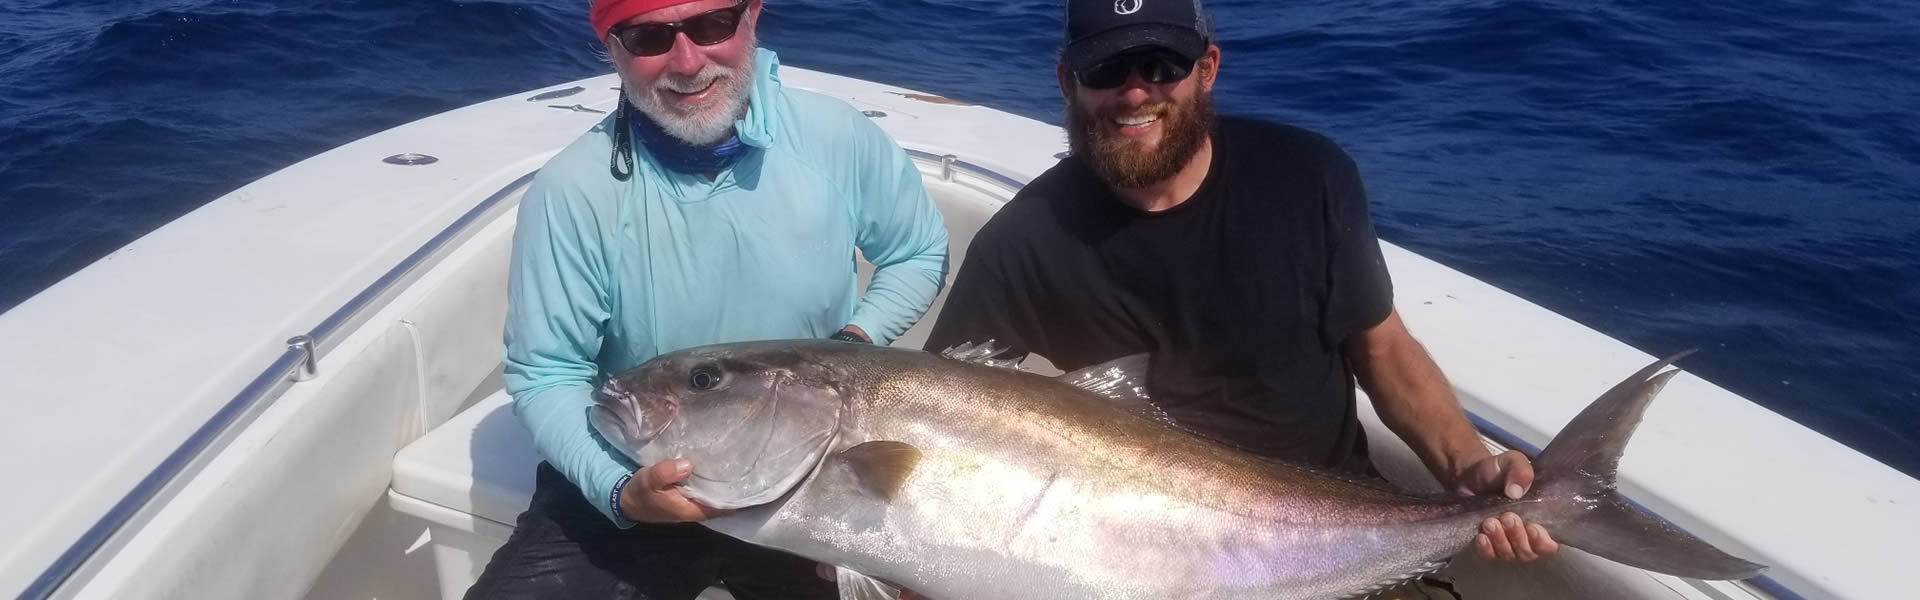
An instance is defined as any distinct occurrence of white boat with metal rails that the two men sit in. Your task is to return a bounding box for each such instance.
[0,67,1920,600]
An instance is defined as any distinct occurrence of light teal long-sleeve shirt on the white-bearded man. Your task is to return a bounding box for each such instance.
[505,50,947,527]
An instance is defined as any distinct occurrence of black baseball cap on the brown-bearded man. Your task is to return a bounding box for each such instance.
[1064,0,1213,71]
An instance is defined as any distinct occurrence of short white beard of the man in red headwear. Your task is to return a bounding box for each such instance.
[626,48,755,146]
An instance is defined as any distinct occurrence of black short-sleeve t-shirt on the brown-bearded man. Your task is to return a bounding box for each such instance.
[925,117,1392,471]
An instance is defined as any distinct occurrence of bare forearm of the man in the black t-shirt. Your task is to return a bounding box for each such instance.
[1348,313,1492,488]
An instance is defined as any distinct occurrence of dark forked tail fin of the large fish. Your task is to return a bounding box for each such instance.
[1515,350,1766,579]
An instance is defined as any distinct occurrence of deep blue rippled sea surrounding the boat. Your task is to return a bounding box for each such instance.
[0,0,1920,475]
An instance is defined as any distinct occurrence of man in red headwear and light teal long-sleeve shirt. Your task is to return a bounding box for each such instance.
[468,0,947,600]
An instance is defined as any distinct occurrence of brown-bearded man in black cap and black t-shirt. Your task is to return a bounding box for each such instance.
[927,0,1557,584]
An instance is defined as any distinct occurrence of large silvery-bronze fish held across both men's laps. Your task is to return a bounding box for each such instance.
[589,340,1764,600]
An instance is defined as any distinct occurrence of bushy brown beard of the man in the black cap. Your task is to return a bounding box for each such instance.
[1068,90,1213,190]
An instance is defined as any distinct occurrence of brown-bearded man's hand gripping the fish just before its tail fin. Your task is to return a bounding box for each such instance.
[1453,450,1559,563]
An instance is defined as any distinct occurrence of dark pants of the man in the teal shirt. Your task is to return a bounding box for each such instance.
[467,463,839,600]
